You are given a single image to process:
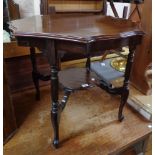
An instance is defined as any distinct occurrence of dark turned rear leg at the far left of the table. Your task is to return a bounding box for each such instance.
[30,47,40,100]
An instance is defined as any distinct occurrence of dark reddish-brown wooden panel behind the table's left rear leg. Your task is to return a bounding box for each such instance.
[5,54,49,93]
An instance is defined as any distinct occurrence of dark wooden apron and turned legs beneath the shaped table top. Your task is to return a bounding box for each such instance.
[10,14,144,148]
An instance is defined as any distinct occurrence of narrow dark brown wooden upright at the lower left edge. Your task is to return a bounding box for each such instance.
[3,64,17,143]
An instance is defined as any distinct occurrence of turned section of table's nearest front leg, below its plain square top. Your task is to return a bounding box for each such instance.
[51,66,59,148]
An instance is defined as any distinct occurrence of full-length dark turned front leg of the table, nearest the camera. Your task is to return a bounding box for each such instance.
[44,39,60,148]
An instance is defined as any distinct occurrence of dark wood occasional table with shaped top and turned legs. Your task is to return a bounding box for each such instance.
[10,15,144,148]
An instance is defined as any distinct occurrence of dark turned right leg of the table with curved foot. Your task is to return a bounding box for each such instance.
[118,46,135,121]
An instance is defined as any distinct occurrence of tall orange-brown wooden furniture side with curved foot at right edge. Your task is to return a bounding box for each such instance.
[131,0,152,95]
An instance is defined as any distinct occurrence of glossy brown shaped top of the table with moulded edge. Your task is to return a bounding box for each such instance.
[10,15,144,42]
